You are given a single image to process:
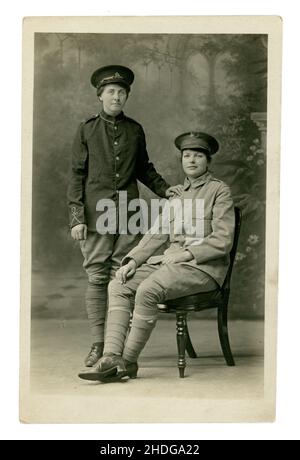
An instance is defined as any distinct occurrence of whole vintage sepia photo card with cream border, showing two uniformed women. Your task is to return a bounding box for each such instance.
[20,16,281,423]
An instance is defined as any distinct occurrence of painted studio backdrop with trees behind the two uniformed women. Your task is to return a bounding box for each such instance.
[32,33,272,319]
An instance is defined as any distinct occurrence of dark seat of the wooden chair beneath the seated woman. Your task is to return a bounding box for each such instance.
[158,289,223,312]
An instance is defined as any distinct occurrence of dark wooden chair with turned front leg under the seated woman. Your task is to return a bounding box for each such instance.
[159,207,242,378]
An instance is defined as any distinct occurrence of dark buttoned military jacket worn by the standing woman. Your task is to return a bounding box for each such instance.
[68,111,169,231]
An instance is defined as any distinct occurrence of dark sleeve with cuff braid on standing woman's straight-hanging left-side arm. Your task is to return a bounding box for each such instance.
[67,123,88,228]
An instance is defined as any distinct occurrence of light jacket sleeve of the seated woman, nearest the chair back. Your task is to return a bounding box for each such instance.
[186,184,235,264]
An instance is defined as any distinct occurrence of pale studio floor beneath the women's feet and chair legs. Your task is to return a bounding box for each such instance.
[24,314,264,422]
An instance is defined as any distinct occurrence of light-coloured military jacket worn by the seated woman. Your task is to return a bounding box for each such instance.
[122,172,235,286]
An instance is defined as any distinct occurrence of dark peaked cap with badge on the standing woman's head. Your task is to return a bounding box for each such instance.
[91,65,134,88]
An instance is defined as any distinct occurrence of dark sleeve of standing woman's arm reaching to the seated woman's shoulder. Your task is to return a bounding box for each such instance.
[137,127,170,198]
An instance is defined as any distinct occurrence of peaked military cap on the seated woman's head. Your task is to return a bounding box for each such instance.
[175,131,219,155]
